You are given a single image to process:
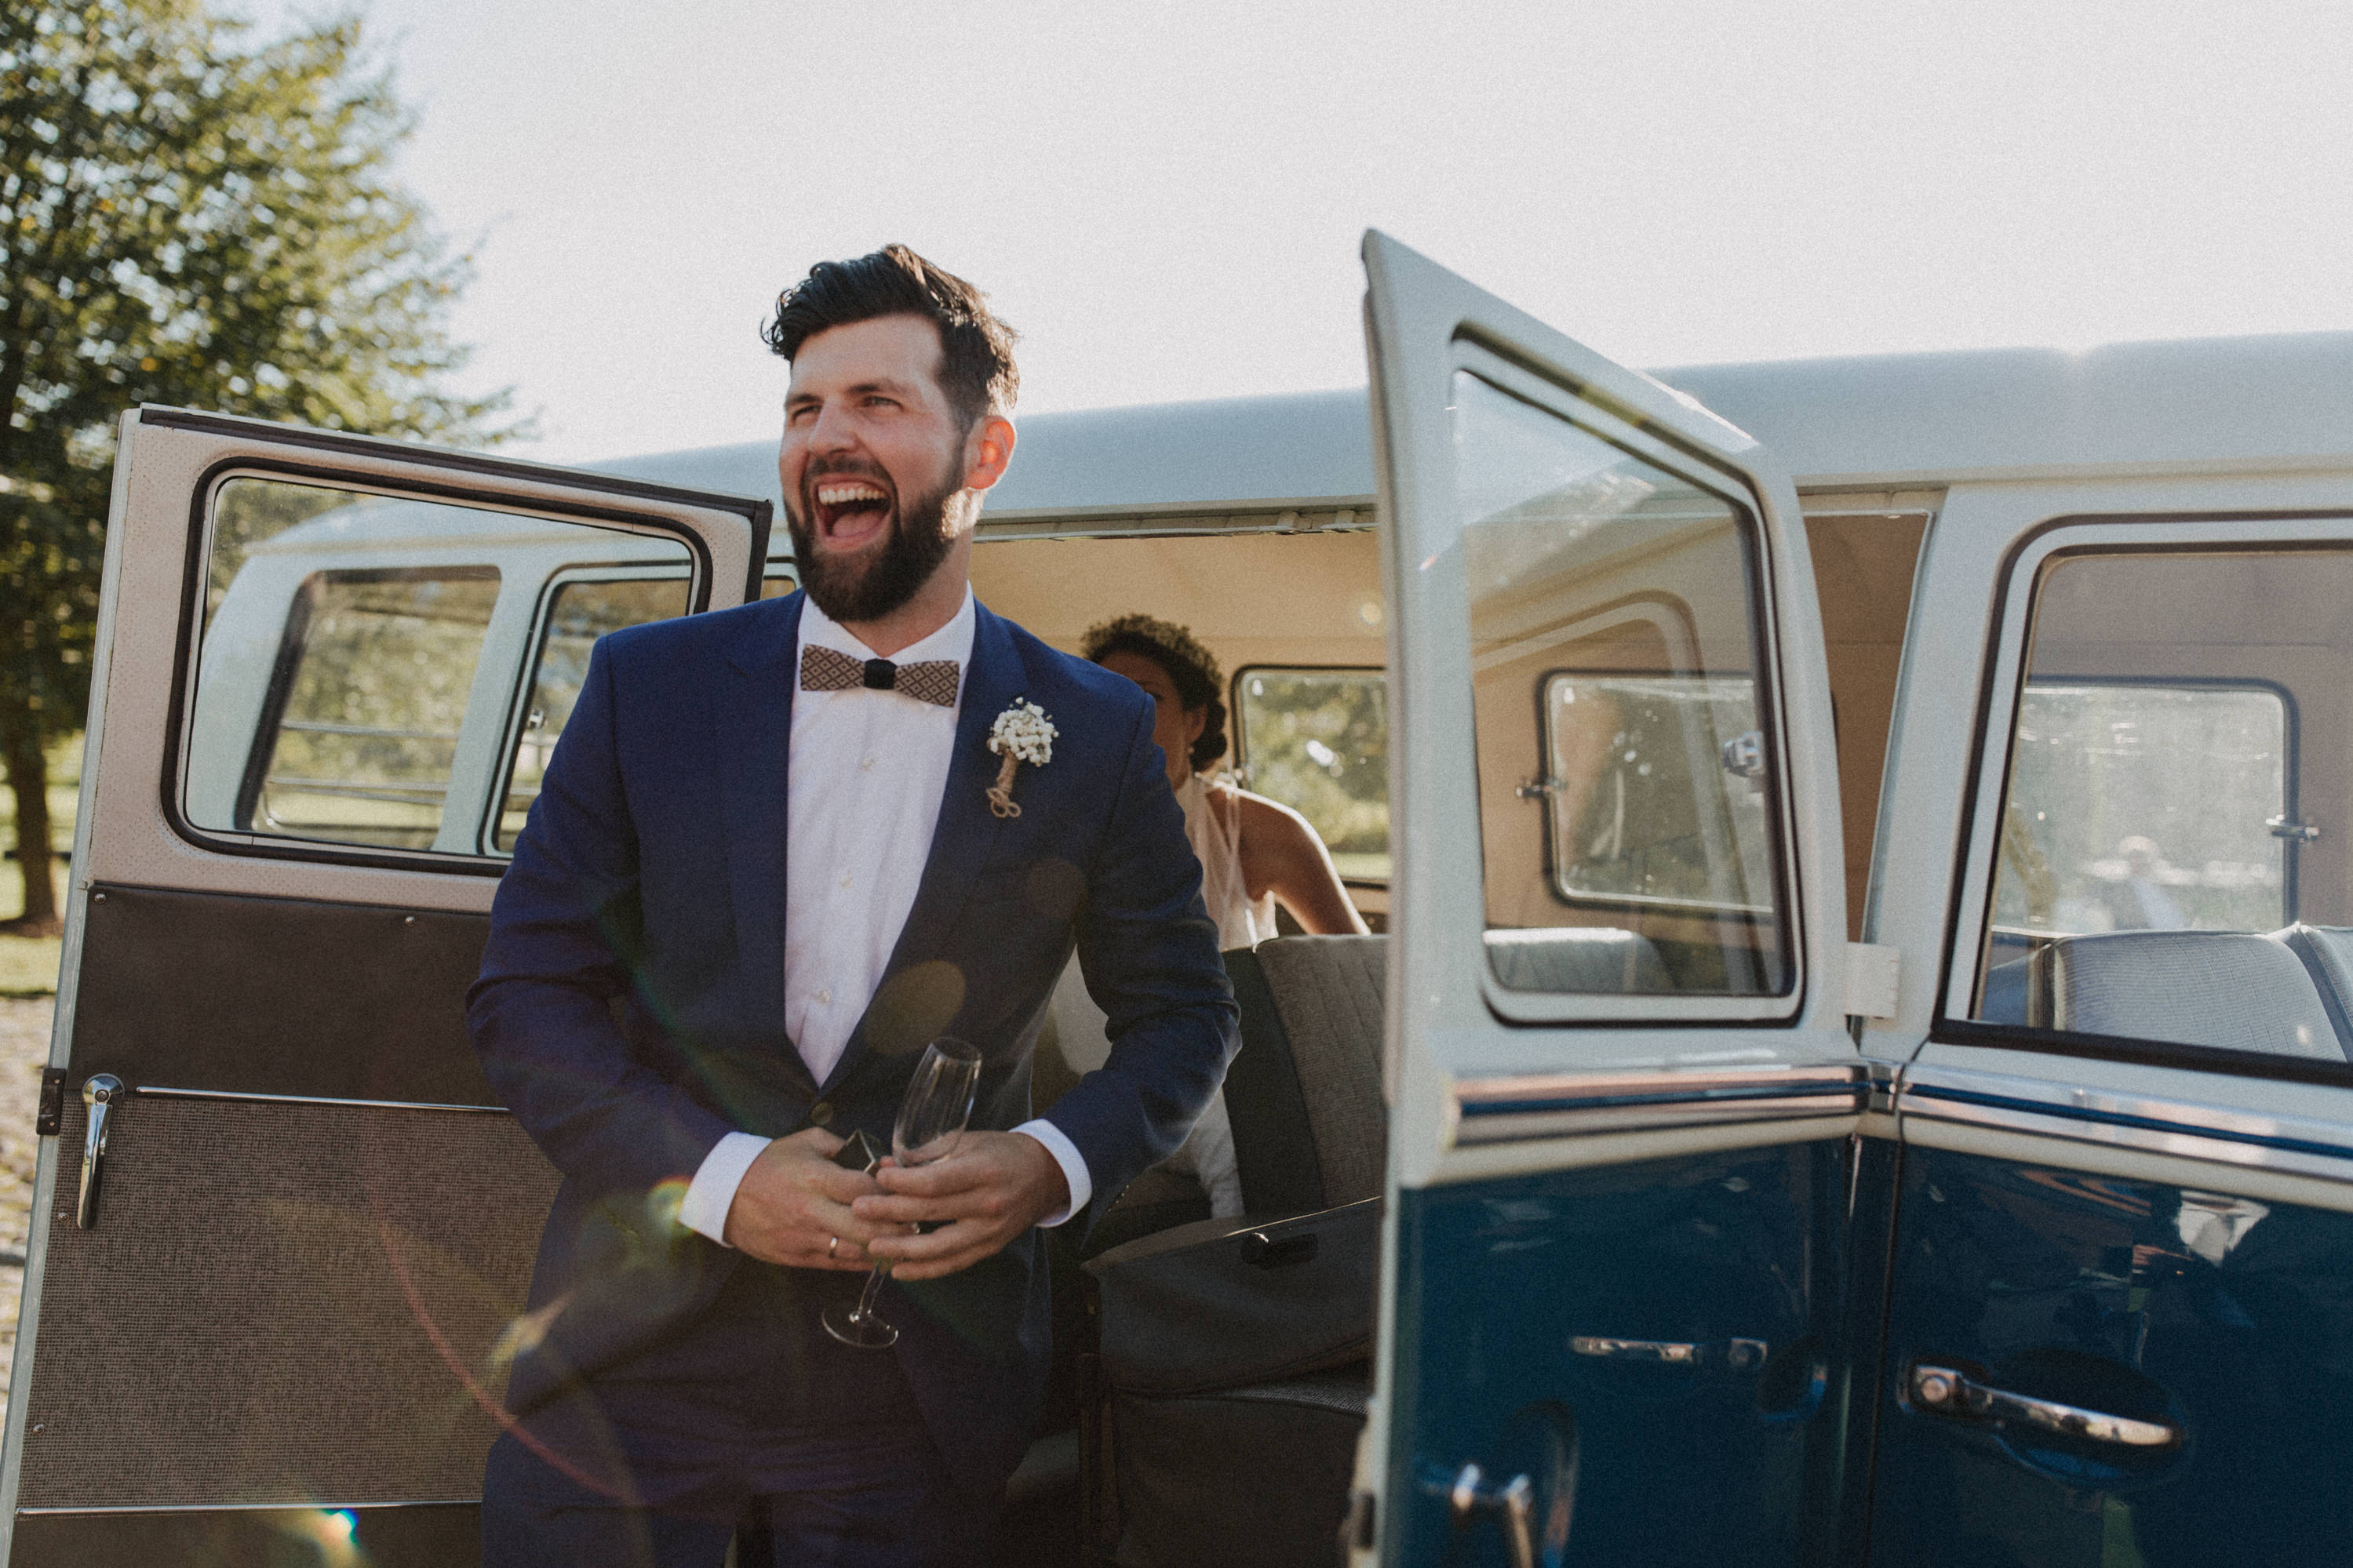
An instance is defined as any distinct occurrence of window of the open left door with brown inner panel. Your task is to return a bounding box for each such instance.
[181,475,692,853]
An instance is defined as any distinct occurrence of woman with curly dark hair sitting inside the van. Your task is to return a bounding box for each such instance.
[1080,616,1364,948]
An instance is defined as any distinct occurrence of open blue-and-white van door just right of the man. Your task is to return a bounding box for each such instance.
[1348,233,1875,1563]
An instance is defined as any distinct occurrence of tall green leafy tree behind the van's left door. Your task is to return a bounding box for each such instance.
[0,0,515,931]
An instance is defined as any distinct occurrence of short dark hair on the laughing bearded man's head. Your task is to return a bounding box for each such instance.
[760,245,1022,430]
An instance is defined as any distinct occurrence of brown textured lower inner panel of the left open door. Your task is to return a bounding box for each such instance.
[16,1090,555,1509]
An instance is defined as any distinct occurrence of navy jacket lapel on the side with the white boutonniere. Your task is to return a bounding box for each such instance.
[826,602,1029,1093]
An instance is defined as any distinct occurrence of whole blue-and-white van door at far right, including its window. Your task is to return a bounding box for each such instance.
[1868,496,2353,1568]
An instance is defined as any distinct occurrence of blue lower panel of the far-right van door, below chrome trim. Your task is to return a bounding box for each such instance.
[1870,1150,2353,1568]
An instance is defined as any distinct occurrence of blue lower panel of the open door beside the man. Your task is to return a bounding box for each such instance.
[1395,1138,1849,1563]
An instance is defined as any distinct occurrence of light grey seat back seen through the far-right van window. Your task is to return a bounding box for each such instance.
[2028,926,2353,1063]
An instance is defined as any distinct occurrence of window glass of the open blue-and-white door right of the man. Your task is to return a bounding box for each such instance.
[1454,372,1790,995]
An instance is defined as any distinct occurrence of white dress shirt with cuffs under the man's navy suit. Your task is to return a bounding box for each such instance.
[678,588,1095,1243]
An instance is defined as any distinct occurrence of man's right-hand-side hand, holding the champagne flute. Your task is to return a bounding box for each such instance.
[845,1133,1071,1279]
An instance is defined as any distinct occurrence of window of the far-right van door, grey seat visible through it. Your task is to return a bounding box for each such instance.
[1972,548,2353,1065]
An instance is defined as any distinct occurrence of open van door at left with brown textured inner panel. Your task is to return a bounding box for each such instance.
[0,409,770,1568]
